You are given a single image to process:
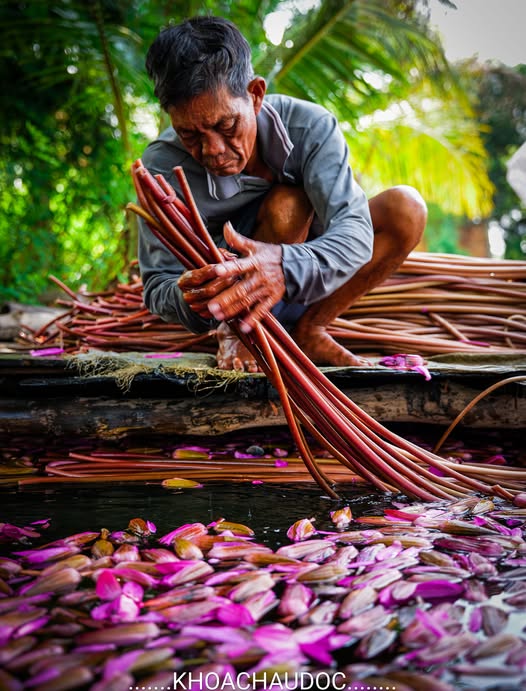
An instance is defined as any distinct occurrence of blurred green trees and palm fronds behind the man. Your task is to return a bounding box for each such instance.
[0,0,526,302]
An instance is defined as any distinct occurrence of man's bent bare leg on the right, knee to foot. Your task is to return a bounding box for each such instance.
[292,185,427,366]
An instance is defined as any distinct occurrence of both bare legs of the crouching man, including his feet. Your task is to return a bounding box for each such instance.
[217,185,427,372]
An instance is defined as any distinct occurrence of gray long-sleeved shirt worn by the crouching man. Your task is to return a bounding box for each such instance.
[139,94,373,332]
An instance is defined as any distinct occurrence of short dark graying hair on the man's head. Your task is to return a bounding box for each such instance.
[146,16,254,110]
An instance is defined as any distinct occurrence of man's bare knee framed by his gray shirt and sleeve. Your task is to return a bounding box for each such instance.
[254,185,314,244]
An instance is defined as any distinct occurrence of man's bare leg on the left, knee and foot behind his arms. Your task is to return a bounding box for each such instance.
[216,185,314,372]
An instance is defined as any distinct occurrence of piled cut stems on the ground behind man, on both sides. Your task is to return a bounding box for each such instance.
[21,247,526,356]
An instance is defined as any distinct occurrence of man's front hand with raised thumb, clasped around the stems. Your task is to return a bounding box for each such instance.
[208,223,285,333]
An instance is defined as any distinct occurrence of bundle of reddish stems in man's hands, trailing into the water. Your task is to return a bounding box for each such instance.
[128,165,526,501]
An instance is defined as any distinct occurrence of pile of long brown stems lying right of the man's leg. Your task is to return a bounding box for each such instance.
[336,252,526,355]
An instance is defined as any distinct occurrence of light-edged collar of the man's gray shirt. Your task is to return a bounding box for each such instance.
[206,101,294,199]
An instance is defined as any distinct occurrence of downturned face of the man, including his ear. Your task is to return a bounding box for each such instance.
[168,78,265,175]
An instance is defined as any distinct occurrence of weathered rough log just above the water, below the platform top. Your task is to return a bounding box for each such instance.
[0,380,526,439]
